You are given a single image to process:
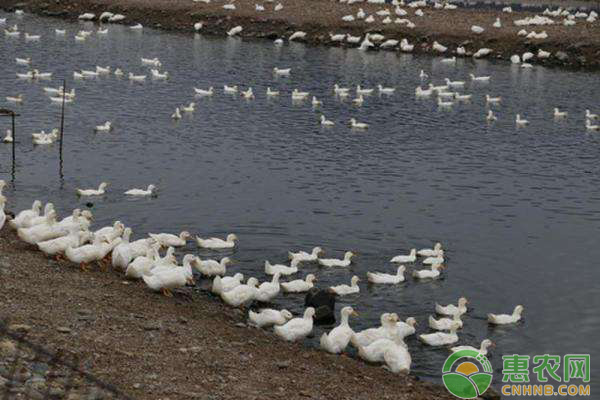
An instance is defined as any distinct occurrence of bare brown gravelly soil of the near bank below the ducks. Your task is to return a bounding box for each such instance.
[0,227,452,400]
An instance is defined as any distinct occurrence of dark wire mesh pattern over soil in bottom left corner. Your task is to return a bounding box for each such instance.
[0,319,131,400]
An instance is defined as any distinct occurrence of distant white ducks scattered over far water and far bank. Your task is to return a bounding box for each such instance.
[0,4,600,145]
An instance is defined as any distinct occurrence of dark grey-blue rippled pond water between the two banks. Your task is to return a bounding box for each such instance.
[0,13,600,396]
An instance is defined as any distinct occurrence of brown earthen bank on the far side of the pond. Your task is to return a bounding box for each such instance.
[0,0,600,71]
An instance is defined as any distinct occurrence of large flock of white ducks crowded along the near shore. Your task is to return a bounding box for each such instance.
[0,175,523,373]
